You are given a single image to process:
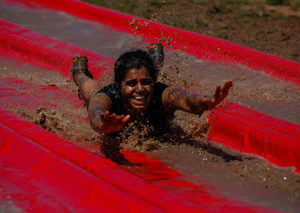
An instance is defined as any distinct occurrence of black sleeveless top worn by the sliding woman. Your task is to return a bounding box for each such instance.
[97,82,174,133]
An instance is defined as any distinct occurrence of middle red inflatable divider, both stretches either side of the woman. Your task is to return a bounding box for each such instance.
[0,19,300,172]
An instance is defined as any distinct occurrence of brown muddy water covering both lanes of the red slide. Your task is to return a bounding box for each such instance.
[0,0,300,212]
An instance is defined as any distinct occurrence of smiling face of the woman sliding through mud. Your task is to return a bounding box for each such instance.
[121,66,154,112]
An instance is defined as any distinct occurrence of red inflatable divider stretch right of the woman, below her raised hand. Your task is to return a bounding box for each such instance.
[208,103,300,173]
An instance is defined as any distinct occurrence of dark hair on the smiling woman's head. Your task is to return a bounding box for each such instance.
[114,50,158,86]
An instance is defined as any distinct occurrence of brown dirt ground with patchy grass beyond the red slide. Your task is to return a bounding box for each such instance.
[85,0,300,62]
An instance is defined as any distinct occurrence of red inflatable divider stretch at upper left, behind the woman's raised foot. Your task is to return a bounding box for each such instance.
[0,19,114,79]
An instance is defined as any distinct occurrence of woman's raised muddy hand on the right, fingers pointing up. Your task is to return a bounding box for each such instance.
[204,80,233,109]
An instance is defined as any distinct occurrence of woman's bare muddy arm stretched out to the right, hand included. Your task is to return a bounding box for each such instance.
[162,80,233,114]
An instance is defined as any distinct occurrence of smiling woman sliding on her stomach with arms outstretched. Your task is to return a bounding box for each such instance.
[72,44,233,161]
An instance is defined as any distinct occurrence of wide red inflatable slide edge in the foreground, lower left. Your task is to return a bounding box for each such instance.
[0,108,273,212]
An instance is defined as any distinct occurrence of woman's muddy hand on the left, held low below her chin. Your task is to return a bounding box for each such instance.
[100,111,130,134]
